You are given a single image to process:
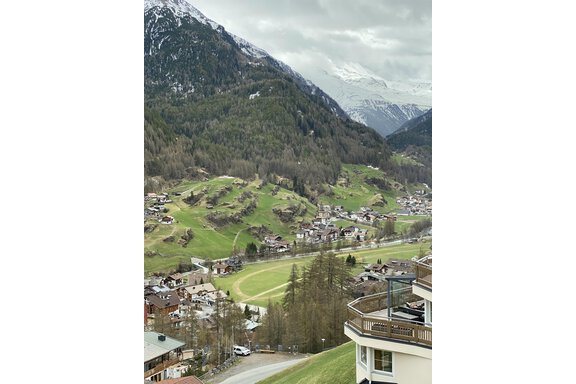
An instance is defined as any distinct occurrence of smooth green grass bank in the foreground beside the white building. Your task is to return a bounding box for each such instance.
[257,341,356,384]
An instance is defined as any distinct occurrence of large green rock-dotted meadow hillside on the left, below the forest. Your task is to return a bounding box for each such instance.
[144,178,316,273]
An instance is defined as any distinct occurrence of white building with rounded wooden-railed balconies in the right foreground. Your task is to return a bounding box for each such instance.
[344,255,432,384]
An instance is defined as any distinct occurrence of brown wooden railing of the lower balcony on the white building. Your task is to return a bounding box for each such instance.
[346,293,432,347]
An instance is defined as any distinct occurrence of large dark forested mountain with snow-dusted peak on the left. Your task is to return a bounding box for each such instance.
[144,0,391,194]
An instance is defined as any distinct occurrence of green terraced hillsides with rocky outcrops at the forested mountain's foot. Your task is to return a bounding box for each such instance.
[144,165,430,273]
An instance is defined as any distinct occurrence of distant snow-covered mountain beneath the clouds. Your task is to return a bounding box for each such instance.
[304,64,432,137]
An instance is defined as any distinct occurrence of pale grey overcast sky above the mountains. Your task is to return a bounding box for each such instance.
[187,0,432,82]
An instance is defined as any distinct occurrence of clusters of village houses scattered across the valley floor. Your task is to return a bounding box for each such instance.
[144,191,432,377]
